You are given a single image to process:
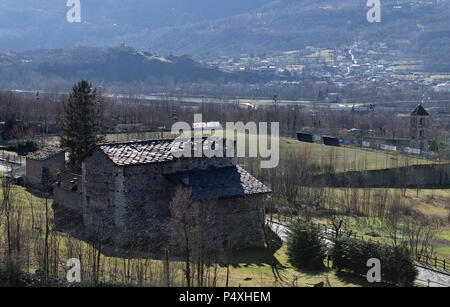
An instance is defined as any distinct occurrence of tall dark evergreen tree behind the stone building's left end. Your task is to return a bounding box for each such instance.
[61,80,104,170]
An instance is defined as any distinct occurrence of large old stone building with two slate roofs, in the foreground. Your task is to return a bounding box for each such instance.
[54,139,270,249]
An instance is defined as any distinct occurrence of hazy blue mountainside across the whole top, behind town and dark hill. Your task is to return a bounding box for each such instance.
[0,0,450,69]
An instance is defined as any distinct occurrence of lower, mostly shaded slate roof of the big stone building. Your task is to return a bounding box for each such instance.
[166,166,271,200]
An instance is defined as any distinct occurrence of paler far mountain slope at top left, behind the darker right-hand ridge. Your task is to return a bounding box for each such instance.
[0,0,270,50]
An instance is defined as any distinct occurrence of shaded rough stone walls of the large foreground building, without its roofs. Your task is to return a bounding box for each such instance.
[81,150,264,249]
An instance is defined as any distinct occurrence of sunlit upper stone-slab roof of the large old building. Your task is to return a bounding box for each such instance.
[98,138,232,166]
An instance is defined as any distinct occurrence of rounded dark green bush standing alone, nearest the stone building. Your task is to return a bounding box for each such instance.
[287,221,326,270]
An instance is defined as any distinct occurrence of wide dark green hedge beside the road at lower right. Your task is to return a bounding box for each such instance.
[332,238,418,286]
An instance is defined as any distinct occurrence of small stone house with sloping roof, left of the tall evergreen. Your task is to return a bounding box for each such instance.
[25,146,66,186]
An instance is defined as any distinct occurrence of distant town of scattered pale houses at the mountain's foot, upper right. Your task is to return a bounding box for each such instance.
[207,41,450,98]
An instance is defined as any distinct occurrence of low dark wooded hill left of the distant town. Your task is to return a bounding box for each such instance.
[0,47,260,89]
